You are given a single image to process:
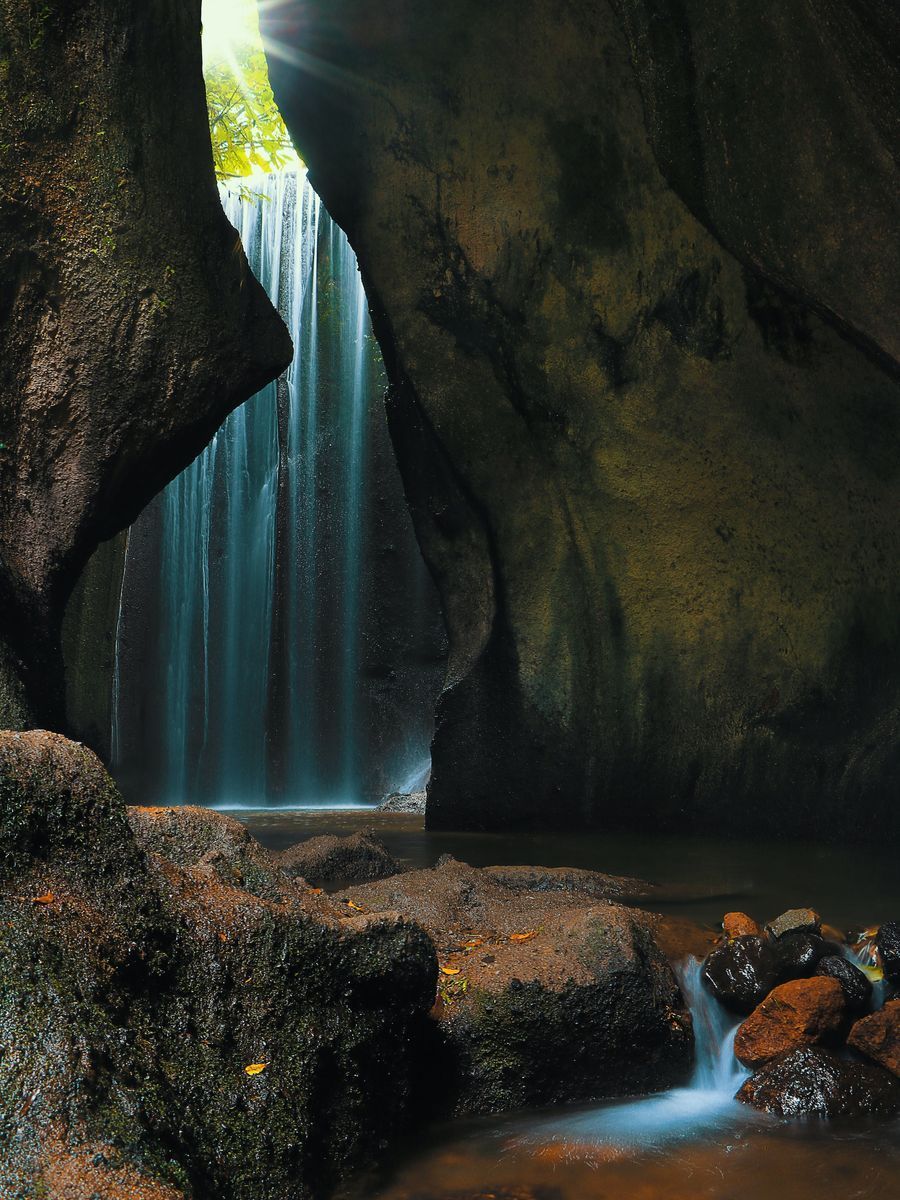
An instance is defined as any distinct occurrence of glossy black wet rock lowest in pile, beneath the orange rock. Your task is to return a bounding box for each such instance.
[737,1046,900,1117]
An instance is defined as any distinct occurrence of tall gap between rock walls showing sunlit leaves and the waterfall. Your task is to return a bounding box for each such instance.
[62,0,445,809]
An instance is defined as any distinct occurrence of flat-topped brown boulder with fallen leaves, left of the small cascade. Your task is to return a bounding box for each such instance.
[348,857,692,1114]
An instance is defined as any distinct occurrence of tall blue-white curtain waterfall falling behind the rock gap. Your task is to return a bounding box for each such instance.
[113,170,446,806]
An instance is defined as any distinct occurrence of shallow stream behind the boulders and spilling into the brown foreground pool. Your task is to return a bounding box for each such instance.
[241,810,900,1200]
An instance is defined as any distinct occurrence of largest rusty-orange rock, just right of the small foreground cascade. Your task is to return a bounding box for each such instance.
[734,978,847,1067]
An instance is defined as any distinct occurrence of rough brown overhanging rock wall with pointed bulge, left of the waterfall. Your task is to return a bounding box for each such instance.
[0,0,290,727]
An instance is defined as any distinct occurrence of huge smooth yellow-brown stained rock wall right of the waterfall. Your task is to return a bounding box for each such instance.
[263,0,900,836]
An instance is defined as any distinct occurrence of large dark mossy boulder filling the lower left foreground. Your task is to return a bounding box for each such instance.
[0,733,437,1200]
